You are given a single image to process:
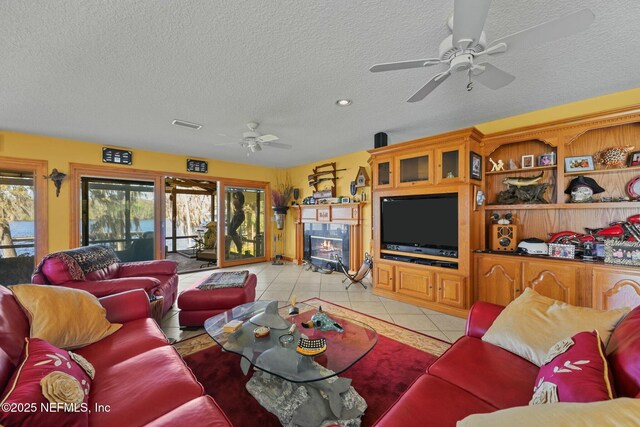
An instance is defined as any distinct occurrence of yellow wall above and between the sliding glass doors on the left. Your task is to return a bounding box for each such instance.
[0,131,277,252]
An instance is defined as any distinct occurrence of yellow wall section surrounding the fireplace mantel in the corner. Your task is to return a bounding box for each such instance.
[281,151,371,260]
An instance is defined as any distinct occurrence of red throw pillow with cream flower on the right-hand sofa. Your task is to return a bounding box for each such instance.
[529,331,614,405]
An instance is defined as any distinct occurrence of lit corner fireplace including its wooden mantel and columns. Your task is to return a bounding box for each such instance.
[293,203,364,272]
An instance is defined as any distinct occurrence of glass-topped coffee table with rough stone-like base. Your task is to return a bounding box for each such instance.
[204,301,378,426]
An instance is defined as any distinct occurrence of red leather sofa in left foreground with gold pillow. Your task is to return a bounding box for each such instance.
[0,286,231,427]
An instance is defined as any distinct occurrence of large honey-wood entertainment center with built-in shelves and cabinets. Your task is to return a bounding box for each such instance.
[370,106,640,317]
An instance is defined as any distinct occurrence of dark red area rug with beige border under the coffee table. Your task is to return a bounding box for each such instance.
[175,299,449,427]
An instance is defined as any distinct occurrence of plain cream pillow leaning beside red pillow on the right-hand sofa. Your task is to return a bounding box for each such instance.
[482,288,630,366]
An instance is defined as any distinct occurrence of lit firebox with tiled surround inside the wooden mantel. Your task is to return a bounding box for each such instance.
[304,223,350,269]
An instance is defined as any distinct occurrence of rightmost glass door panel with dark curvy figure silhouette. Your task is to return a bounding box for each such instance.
[224,187,265,261]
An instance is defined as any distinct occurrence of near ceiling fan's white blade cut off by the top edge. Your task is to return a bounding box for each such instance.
[453,0,491,49]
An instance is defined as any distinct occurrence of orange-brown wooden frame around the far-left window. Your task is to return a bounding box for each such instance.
[0,157,49,263]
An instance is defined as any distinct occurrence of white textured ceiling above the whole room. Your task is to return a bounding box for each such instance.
[0,0,640,167]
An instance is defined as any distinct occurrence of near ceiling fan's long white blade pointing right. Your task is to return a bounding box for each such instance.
[487,9,595,55]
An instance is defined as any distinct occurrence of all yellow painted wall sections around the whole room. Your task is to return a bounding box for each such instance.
[0,88,640,257]
